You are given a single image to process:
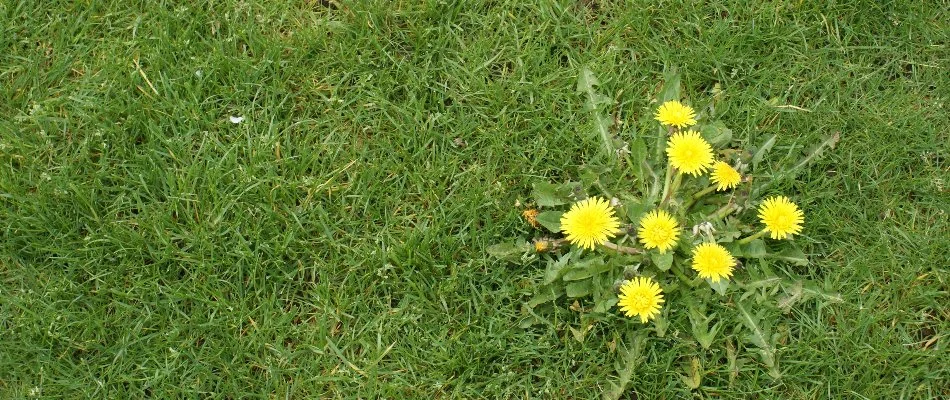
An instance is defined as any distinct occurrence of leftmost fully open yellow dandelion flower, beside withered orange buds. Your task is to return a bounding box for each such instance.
[561,197,620,250]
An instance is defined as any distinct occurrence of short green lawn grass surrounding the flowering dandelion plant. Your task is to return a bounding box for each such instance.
[0,0,950,399]
